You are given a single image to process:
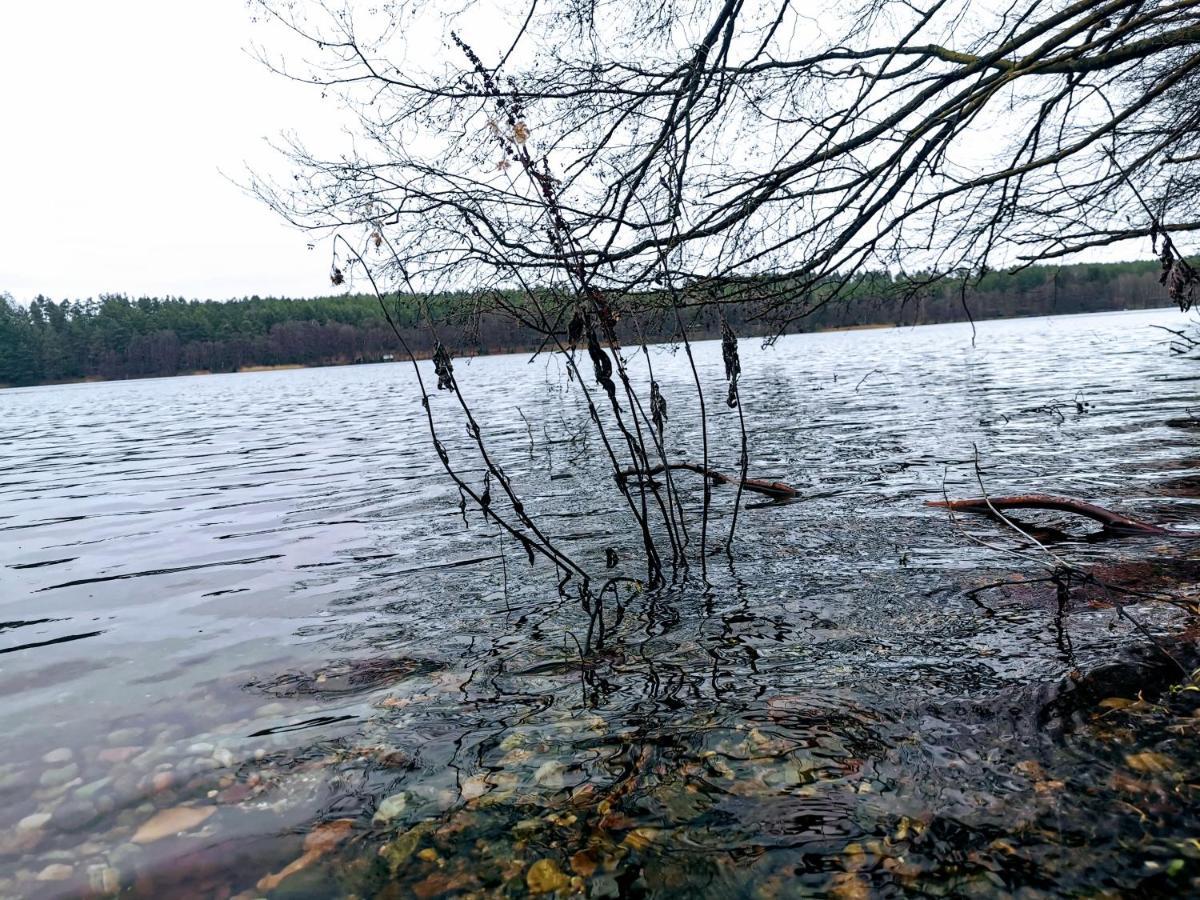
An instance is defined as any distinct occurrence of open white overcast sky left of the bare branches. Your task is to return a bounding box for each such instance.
[0,0,332,300]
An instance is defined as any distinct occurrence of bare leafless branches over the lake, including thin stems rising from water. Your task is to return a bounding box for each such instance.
[243,0,1200,602]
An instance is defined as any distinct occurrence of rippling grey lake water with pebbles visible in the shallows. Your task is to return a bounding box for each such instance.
[0,311,1200,898]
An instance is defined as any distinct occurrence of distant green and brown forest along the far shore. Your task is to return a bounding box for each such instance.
[0,262,1168,385]
